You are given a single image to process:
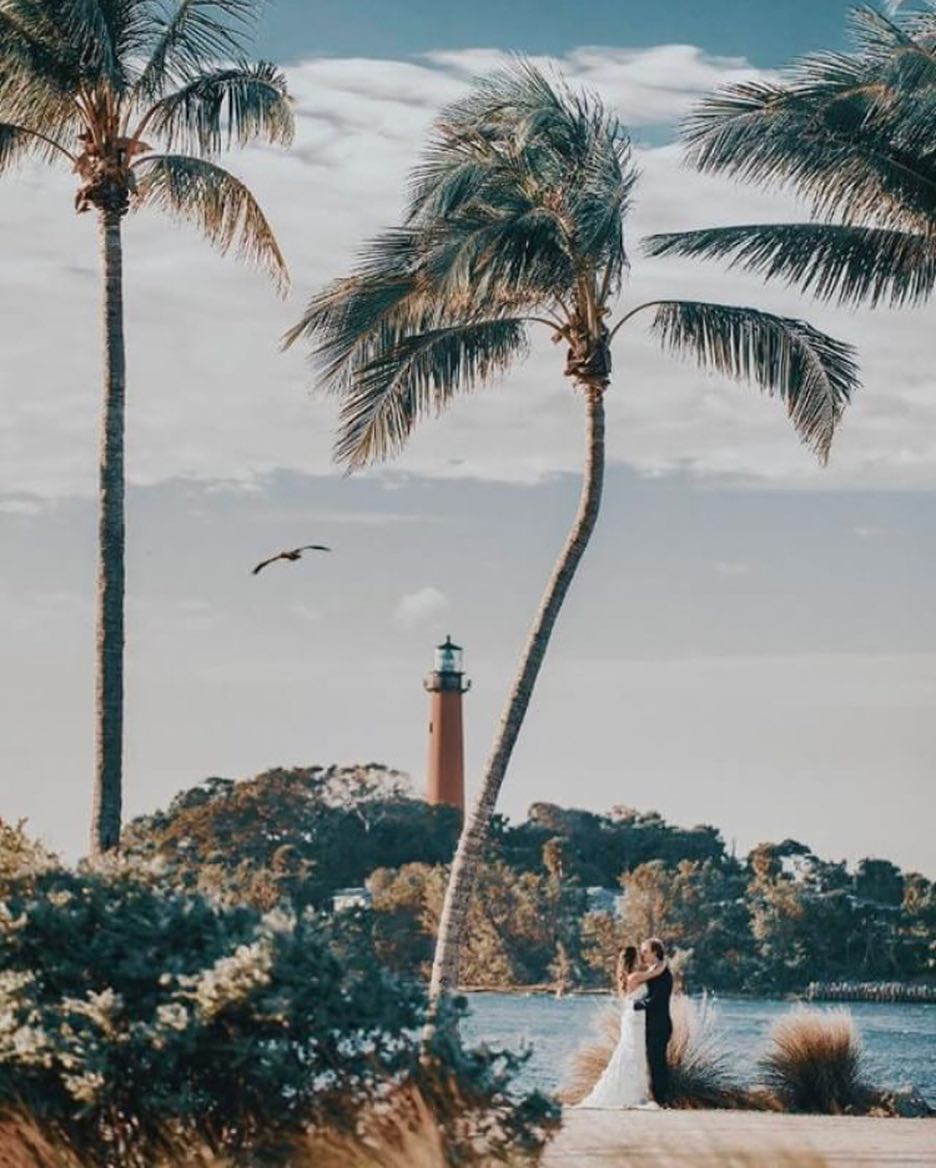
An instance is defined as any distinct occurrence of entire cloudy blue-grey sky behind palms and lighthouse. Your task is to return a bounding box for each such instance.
[0,0,936,876]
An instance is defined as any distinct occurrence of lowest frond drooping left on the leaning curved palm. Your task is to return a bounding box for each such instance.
[335,320,526,468]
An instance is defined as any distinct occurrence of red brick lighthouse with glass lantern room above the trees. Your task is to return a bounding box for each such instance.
[423,637,471,812]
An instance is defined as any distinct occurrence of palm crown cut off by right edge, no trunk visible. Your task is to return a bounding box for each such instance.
[647,5,936,307]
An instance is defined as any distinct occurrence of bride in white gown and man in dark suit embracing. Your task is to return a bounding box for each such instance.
[578,937,673,1110]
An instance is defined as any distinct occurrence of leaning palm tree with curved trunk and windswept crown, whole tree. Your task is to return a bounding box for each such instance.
[286,63,857,1000]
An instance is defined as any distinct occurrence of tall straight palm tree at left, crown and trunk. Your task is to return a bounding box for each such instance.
[0,0,292,851]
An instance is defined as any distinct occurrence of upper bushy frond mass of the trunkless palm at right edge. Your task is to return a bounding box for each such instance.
[685,8,936,231]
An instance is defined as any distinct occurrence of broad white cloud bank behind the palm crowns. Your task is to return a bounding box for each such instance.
[0,46,936,497]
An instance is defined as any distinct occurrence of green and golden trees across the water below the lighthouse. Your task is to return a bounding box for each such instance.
[125,766,936,992]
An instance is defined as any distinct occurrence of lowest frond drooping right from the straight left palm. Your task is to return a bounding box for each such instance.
[136,154,289,292]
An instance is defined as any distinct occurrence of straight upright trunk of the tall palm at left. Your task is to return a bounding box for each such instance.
[91,209,125,854]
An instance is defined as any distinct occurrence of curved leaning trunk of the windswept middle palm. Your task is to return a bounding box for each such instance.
[429,385,604,1002]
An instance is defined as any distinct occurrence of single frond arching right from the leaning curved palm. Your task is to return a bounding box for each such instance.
[651,300,859,463]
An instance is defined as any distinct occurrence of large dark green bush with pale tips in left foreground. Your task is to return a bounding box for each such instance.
[0,827,554,1168]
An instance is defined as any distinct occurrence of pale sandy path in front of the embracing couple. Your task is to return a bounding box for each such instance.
[543,1111,936,1168]
